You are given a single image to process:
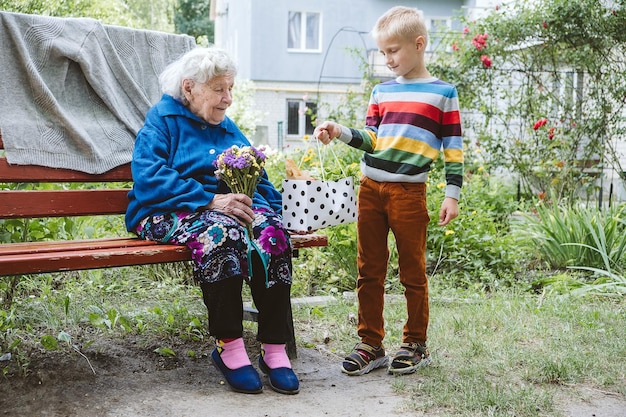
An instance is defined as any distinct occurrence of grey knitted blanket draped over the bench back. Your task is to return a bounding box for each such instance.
[0,12,195,174]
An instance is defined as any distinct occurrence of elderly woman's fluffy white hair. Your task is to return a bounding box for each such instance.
[159,47,237,100]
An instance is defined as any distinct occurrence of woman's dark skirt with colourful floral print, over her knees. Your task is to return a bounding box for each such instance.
[136,208,291,288]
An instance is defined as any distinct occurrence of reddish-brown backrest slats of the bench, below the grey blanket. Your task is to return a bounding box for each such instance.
[0,133,132,219]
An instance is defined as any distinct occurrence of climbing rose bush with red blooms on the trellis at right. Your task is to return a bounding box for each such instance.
[430,0,626,199]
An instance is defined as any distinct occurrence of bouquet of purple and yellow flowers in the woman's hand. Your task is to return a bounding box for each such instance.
[215,145,265,239]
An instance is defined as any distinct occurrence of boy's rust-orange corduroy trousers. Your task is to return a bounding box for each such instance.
[357,176,430,346]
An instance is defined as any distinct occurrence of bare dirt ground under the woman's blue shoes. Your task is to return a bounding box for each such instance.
[0,336,626,417]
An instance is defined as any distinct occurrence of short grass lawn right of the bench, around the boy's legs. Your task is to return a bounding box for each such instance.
[296,289,626,417]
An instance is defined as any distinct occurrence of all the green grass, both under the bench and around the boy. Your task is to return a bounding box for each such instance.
[0,268,626,417]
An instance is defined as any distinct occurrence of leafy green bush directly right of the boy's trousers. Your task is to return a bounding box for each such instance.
[428,162,524,289]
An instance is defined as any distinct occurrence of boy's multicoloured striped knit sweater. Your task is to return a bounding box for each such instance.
[338,77,463,200]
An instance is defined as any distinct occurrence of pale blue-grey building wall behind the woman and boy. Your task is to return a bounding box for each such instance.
[211,0,626,201]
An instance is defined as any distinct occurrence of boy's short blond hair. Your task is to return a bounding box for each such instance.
[372,6,428,44]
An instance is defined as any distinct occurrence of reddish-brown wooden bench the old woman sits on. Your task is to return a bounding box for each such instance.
[0,133,328,357]
